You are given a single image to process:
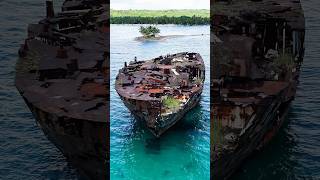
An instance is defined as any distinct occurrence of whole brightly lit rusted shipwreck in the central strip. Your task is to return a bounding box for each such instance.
[115,52,205,137]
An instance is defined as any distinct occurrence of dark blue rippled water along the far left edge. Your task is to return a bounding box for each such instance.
[0,0,78,179]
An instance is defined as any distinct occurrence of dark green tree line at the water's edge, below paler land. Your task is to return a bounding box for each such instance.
[110,16,210,25]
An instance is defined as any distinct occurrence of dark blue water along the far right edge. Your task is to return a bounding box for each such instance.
[233,0,320,180]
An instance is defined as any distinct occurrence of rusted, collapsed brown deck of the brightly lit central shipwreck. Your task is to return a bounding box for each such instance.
[116,53,204,101]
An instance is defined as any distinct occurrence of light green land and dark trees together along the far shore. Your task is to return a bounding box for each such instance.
[110,10,210,25]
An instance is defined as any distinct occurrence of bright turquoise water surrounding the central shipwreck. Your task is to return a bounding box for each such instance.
[110,25,210,180]
